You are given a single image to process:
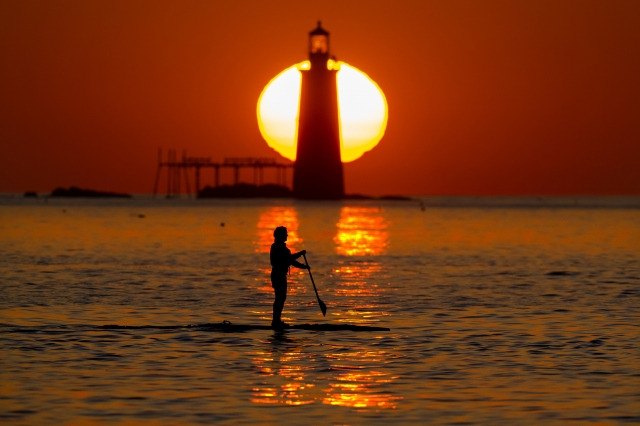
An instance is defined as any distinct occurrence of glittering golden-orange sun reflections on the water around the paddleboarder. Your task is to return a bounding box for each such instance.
[251,206,402,409]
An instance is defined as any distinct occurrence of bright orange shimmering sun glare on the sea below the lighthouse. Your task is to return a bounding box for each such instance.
[251,206,403,411]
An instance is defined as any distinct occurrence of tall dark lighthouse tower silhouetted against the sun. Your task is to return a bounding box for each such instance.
[293,21,344,200]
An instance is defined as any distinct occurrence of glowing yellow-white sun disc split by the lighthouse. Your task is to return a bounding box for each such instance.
[257,61,388,163]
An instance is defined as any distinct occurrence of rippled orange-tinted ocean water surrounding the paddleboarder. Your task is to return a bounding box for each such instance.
[0,197,640,425]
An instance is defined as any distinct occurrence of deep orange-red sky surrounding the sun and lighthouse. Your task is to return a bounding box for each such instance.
[0,0,640,195]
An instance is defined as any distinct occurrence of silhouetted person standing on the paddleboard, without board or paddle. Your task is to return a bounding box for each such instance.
[270,226,309,328]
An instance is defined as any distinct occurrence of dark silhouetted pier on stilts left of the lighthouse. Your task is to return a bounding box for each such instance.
[153,149,293,198]
